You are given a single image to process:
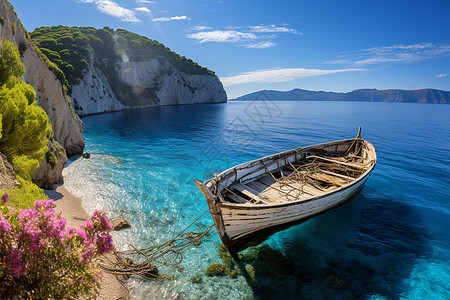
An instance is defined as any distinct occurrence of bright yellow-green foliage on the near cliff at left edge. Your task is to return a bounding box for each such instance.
[0,41,51,180]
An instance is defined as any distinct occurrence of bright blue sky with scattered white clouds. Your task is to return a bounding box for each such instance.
[10,0,450,98]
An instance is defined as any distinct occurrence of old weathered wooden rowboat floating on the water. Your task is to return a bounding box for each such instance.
[195,128,376,253]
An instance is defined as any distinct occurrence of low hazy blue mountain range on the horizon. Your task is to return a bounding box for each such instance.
[233,89,450,104]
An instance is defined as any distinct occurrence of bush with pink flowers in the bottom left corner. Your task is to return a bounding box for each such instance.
[0,194,112,299]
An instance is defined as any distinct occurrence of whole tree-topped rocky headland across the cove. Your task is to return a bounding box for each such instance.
[31,26,227,116]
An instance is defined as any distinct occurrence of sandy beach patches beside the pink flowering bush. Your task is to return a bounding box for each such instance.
[45,186,129,300]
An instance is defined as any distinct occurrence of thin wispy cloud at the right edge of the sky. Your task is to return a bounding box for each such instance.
[327,43,450,66]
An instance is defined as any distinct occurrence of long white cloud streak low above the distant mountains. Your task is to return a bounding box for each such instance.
[220,68,363,87]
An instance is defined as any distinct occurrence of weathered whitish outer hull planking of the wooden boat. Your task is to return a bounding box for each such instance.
[196,131,376,252]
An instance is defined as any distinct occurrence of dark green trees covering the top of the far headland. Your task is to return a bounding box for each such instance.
[30,25,214,94]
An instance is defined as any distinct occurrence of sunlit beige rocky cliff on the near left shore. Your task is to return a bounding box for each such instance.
[0,0,84,186]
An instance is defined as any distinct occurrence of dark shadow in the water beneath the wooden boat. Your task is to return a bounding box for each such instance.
[234,194,432,299]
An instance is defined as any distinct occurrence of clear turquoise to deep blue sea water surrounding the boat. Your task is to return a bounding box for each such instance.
[60,101,450,299]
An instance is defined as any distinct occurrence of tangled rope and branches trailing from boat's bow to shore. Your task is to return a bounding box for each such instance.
[98,210,216,281]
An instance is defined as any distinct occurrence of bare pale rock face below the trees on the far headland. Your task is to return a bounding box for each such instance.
[72,53,227,116]
